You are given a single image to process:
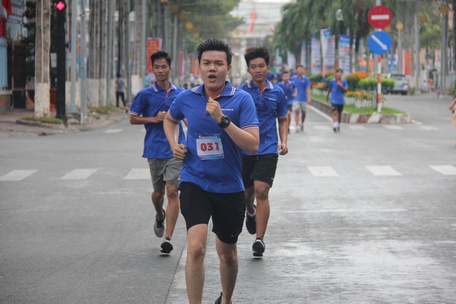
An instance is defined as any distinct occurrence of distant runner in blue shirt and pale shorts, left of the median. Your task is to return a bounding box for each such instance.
[291,64,310,132]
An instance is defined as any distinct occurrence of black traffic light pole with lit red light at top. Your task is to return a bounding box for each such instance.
[54,0,67,123]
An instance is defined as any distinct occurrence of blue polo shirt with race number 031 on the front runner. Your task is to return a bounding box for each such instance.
[169,81,258,193]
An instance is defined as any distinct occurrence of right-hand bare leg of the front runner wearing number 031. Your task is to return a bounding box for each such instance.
[217,237,238,304]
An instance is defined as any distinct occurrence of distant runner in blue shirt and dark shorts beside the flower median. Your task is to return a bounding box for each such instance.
[326,69,348,133]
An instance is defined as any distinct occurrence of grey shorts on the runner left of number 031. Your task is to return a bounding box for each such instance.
[147,158,182,191]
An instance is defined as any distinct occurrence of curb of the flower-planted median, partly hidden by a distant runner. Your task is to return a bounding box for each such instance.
[312,100,412,124]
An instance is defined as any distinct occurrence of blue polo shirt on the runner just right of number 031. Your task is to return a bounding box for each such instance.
[239,80,288,155]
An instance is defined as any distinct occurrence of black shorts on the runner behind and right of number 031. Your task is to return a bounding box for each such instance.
[242,154,279,188]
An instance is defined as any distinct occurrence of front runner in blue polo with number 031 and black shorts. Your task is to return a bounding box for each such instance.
[164,39,260,304]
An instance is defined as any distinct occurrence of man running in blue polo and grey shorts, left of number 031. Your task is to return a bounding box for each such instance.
[130,51,185,254]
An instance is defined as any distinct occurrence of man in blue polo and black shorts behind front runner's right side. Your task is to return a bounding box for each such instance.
[239,47,288,257]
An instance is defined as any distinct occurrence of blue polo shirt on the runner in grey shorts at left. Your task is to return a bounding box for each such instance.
[130,82,185,158]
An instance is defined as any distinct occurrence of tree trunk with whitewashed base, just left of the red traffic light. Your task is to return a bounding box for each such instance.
[35,0,51,117]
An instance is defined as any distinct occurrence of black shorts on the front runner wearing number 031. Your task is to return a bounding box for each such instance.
[179,182,245,244]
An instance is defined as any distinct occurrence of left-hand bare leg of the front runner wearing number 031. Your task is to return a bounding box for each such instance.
[185,224,208,304]
